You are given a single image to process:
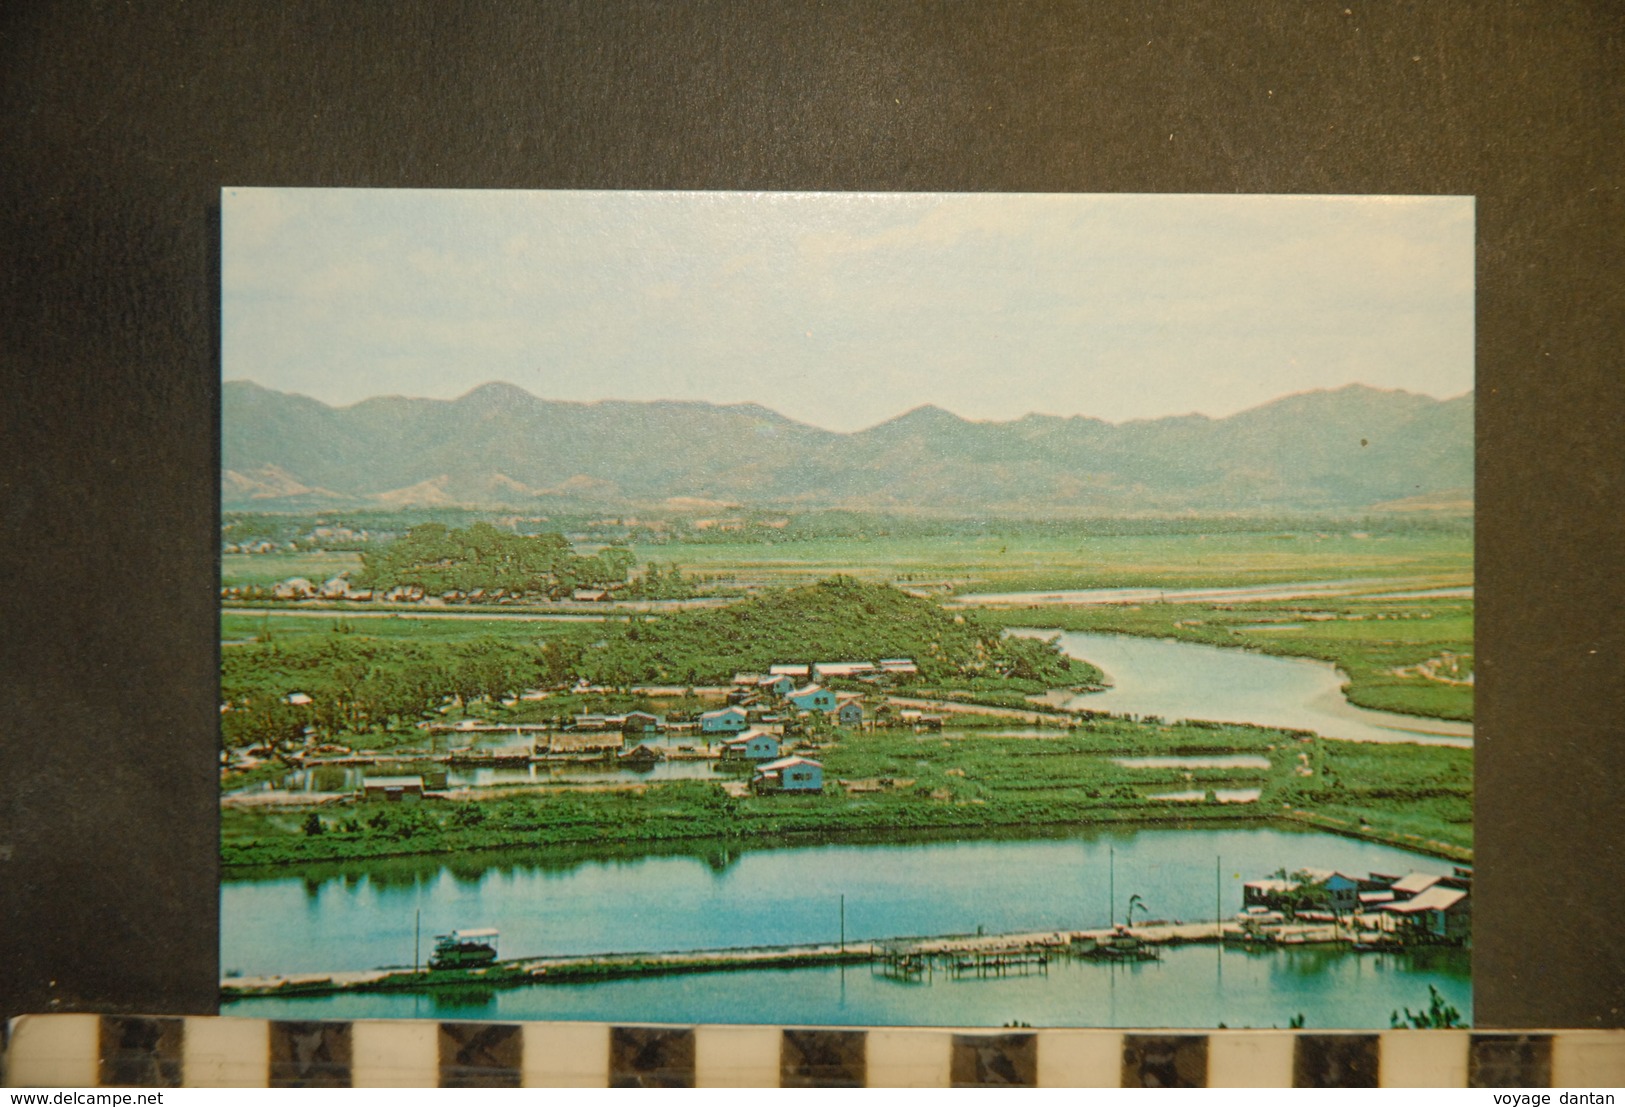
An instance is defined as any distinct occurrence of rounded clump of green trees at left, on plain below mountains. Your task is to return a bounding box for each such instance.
[361,522,634,597]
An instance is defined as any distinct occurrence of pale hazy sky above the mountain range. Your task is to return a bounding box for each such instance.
[221,189,1474,431]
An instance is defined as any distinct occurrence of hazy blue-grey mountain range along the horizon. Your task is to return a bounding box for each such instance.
[221,380,1472,515]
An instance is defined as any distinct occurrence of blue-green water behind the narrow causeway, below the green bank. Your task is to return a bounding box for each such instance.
[221,827,1450,975]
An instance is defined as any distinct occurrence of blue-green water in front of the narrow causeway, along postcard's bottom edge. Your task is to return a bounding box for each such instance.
[221,946,1472,1029]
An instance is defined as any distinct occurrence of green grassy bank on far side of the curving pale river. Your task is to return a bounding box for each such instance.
[980,598,1472,722]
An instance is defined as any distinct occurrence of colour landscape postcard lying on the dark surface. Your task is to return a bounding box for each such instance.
[219,189,1474,1029]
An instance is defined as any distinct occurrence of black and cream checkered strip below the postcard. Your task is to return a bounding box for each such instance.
[3,1014,1625,1087]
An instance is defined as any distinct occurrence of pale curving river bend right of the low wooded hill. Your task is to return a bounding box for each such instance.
[1011,629,1472,746]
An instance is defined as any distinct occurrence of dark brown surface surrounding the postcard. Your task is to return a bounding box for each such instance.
[0,2,1625,1027]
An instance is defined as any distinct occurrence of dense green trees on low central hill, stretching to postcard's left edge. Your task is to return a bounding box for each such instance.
[221,579,1099,748]
